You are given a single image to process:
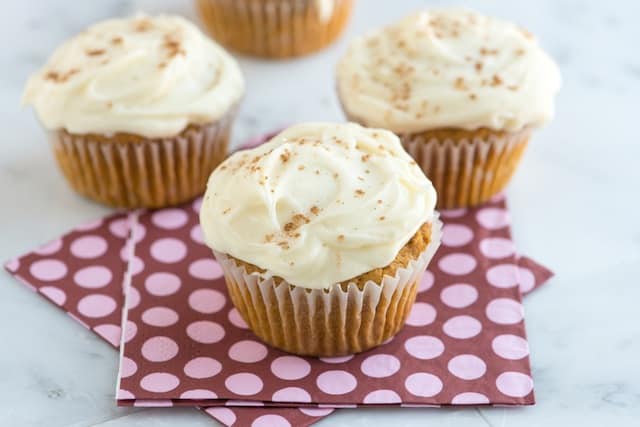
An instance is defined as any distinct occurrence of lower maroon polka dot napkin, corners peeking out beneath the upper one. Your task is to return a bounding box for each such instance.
[5,199,552,426]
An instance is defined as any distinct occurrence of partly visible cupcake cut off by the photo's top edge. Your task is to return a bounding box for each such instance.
[197,0,353,58]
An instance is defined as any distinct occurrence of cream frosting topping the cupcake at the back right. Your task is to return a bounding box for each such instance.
[337,9,561,133]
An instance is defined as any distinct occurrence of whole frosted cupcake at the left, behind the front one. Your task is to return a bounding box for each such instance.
[23,15,244,208]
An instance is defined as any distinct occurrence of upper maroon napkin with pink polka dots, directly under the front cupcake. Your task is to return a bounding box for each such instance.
[118,197,549,408]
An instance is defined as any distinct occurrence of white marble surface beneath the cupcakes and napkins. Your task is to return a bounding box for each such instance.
[0,0,640,427]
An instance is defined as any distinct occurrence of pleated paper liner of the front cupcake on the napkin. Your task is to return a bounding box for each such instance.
[213,215,442,356]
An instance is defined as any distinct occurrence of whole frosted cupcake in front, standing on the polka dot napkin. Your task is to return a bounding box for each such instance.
[200,123,441,356]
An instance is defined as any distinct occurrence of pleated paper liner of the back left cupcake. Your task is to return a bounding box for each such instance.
[50,111,235,208]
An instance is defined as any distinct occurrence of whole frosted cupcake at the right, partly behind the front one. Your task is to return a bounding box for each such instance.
[337,9,561,208]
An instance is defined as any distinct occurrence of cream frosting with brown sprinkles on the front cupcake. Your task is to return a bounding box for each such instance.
[200,123,436,289]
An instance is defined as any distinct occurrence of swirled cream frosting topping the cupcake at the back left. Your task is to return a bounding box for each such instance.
[23,15,244,138]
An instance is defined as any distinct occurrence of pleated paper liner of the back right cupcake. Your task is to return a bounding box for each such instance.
[400,129,531,209]
